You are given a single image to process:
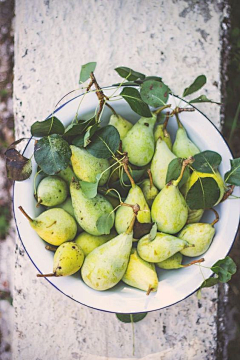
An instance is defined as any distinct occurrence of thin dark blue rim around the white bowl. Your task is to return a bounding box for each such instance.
[12,85,240,314]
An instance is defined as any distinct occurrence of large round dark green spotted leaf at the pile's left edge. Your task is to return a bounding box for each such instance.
[34,134,71,175]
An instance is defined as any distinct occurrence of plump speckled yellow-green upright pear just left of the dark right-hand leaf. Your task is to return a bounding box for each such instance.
[151,181,188,234]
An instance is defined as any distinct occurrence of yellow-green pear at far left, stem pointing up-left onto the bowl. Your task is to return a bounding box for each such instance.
[19,206,77,246]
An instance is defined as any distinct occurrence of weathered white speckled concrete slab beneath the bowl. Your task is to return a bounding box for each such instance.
[13,0,229,360]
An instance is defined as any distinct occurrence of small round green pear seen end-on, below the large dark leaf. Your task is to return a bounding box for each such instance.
[37,175,68,206]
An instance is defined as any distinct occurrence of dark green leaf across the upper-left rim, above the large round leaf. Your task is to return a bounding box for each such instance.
[31,116,65,136]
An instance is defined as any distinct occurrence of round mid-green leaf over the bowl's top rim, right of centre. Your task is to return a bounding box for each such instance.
[140,80,170,108]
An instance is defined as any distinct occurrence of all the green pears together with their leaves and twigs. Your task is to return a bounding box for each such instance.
[5,62,240,322]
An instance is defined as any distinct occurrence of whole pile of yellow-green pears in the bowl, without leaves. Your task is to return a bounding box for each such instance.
[17,112,224,294]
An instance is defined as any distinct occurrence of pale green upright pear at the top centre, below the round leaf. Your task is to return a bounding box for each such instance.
[122,115,157,166]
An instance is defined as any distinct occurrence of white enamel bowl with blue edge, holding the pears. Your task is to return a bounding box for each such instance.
[13,88,240,313]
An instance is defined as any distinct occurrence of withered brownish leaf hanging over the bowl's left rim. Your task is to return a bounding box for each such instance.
[5,148,32,181]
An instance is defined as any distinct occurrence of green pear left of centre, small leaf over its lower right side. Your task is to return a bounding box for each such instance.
[70,181,114,235]
